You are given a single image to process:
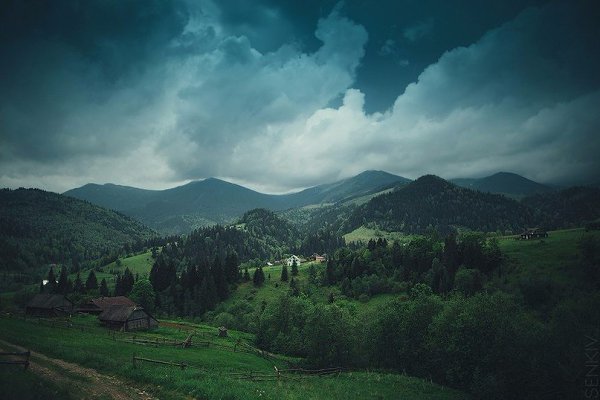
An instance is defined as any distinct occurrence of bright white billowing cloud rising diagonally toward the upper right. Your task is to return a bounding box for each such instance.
[218,1,600,189]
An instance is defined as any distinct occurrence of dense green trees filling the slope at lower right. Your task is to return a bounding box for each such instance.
[252,235,600,399]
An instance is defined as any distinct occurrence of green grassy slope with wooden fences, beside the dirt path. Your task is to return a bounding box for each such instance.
[0,316,468,400]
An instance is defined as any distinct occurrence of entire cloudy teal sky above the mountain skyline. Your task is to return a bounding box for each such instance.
[0,0,600,193]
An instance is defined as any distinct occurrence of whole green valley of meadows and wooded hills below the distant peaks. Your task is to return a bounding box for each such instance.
[0,173,600,399]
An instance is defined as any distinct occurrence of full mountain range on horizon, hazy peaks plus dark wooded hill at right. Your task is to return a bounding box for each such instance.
[59,171,593,234]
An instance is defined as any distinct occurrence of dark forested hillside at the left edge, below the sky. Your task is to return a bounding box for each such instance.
[0,189,156,272]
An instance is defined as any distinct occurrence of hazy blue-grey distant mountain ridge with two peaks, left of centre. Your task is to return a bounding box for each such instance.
[64,171,410,234]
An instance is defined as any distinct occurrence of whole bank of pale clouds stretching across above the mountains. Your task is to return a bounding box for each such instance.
[0,2,600,192]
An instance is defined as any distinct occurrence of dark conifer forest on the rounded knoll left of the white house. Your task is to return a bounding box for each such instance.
[144,209,344,317]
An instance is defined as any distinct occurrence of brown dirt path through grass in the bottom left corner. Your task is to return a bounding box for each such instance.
[0,340,154,400]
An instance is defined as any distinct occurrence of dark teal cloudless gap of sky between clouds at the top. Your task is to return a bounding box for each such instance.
[213,0,548,112]
